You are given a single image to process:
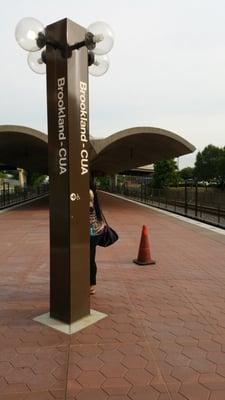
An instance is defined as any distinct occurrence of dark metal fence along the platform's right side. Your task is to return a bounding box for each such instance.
[108,179,225,228]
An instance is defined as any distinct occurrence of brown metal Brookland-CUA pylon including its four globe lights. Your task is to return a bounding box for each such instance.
[16,18,113,324]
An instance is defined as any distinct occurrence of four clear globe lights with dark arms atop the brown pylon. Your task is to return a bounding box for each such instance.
[15,17,114,76]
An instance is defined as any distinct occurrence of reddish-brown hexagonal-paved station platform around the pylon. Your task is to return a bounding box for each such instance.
[0,195,225,400]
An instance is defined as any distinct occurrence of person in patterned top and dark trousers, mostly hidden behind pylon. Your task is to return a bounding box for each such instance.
[89,188,105,294]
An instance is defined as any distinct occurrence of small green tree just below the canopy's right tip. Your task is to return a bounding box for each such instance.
[153,160,179,188]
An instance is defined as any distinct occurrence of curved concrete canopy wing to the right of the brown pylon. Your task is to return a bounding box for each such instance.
[91,127,195,173]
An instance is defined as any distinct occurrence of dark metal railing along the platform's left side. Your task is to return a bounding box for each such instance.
[0,184,49,209]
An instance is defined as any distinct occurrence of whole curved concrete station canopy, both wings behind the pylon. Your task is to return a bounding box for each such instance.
[0,125,195,175]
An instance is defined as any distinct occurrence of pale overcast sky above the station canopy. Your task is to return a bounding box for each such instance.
[0,0,225,168]
